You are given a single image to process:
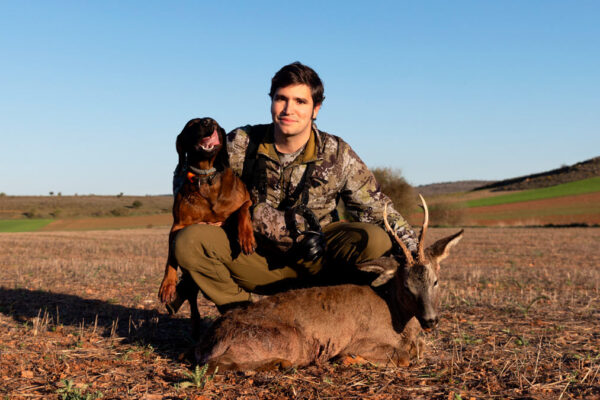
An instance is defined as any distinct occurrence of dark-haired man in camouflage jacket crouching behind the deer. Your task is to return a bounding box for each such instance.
[164,62,417,312]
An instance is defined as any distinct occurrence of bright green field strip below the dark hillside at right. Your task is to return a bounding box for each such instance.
[467,177,600,207]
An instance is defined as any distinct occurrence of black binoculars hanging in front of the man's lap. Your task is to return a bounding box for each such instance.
[285,205,326,262]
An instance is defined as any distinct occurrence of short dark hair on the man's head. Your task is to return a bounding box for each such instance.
[269,61,325,106]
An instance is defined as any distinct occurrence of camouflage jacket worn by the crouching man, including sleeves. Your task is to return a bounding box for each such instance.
[227,124,417,252]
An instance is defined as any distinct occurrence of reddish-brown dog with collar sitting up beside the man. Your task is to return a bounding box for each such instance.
[158,118,256,334]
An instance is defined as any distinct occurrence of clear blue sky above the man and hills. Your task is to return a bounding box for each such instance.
[0,1,600,195]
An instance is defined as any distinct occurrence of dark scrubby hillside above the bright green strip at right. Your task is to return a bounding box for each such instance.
[473,157,600,191]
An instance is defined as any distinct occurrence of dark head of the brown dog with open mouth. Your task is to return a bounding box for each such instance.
[176,118,229,169]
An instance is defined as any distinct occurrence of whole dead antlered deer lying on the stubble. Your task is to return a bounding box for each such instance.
[196,197,463,370]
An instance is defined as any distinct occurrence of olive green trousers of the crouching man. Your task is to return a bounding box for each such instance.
[175,222,392,306]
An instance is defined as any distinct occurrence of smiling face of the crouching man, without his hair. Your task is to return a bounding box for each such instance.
[271,84,321,141]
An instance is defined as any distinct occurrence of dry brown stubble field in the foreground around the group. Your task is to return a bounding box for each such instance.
[0,228,600,400]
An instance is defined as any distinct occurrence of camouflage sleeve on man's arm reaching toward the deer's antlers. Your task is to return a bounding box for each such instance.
[342,144,418,252]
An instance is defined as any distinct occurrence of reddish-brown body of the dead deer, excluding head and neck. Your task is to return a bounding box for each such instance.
[196,285,420,370]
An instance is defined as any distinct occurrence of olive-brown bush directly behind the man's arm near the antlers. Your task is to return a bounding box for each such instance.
[372,168,417,217]
